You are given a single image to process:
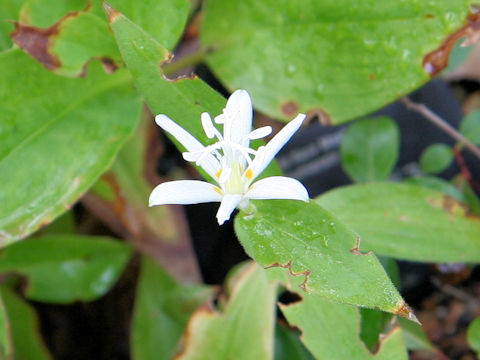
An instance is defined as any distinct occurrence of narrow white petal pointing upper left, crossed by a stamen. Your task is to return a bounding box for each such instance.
[155,114,220,179]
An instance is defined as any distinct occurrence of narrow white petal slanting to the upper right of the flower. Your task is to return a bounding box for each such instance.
[250,114,306,179]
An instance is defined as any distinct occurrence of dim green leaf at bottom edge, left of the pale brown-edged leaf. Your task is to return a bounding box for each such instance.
[131,257,212,360]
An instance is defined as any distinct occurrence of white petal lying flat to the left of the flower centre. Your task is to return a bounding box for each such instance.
[148,180,222,206]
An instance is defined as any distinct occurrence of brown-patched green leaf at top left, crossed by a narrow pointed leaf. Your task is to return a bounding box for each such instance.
[12,0,189,76]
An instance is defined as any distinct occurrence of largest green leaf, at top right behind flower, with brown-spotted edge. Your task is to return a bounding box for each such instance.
[201,0,474,124]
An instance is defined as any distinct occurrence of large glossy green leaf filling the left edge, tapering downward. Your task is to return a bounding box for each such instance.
[0,49,140,246]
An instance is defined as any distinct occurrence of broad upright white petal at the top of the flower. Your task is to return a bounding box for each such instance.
[223,90,253,147]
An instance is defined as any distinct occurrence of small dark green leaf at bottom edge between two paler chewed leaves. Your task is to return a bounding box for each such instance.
[274,324,313,360]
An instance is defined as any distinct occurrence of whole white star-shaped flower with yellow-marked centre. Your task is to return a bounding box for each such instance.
[149,90,309,225]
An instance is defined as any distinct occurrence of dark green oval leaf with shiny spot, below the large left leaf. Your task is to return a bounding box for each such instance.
[0,235,131,304]
